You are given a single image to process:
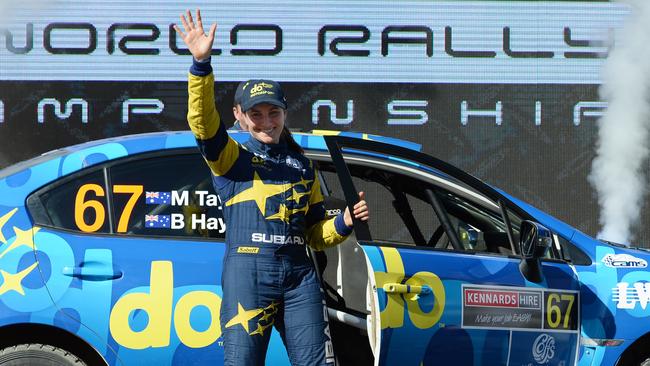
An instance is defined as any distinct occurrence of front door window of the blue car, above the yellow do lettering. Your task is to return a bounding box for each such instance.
[319,159,521,255]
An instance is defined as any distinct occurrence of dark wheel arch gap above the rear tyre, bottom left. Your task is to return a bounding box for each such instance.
[0,323,108,366]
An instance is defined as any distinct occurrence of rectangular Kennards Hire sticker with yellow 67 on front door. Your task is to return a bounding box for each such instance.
[462,285,578,331]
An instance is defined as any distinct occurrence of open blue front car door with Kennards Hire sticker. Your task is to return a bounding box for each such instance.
[320,136,580,365]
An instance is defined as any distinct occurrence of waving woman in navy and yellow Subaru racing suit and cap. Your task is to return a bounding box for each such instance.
[175,10,368,365]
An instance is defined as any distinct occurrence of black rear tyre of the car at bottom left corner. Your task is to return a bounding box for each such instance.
[0,343,86,366]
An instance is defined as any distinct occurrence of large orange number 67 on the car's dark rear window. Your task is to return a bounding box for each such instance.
[74,183,144,233]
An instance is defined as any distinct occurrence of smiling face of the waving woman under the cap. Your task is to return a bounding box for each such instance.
[240,103,287,144]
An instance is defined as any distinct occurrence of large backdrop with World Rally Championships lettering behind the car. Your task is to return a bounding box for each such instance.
[0,0,650,246]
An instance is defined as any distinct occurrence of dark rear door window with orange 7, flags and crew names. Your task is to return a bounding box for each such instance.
[110,154,225,238]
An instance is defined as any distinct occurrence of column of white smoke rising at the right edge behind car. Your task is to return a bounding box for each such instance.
[589,0,650,243]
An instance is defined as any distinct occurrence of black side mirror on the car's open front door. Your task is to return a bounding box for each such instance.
[519,221,553,283]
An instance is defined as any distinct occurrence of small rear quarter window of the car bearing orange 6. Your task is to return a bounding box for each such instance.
[36,170,109,233]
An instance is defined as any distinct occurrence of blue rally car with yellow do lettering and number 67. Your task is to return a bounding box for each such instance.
[0,131,650,366]
